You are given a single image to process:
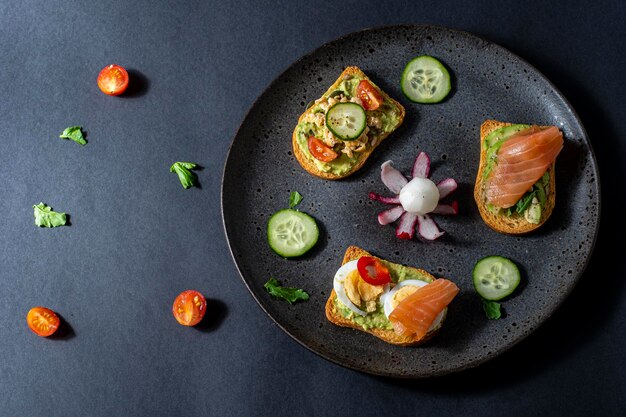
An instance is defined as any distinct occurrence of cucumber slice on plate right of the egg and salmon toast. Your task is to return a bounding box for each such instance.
[472,256,520,301]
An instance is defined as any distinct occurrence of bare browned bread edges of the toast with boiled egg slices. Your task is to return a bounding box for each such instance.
[326,246,447,346]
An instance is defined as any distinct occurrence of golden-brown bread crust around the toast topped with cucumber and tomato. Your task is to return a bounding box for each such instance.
[291,67,406,180]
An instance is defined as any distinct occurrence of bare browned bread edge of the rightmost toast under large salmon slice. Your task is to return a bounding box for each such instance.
[474,120,556,235]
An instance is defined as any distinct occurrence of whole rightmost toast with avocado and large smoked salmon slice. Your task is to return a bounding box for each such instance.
[474,120,563,235]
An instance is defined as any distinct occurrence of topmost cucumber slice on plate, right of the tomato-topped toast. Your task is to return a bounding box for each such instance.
[400,55,452,104]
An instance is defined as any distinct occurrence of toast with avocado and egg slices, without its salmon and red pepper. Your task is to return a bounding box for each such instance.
[326,246,458,346]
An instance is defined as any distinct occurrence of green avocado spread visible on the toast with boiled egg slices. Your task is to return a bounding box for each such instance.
[333,259,432,330]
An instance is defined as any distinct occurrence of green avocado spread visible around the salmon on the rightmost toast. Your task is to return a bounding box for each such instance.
[483,124,550,224]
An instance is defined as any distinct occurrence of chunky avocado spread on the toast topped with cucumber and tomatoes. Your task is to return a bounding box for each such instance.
[296,75,402,175]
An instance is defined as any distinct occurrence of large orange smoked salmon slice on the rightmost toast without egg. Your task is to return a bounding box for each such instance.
[487,126,563,208]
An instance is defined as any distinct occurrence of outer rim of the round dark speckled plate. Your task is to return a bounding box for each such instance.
[220,24,602,379]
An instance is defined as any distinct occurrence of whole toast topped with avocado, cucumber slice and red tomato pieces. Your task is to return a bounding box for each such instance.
[292,67,405,180]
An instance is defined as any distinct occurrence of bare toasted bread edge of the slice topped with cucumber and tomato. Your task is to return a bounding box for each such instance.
[292,67,405,180]
